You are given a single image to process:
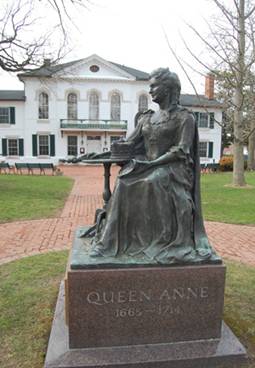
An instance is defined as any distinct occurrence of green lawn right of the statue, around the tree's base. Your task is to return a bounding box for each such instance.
[201,172,255,224]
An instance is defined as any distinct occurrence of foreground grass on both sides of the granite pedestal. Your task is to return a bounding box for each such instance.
[0,252,255,368]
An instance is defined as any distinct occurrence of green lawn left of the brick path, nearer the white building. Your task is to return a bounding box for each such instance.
[0,175,73,222]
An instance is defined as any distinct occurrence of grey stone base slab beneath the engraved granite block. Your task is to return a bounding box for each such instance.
[45,285,246,368]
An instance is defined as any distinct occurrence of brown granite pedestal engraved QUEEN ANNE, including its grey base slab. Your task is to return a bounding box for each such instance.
[45,231,246,368]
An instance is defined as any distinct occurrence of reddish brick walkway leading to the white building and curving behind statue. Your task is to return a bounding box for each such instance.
[0,166,255,266]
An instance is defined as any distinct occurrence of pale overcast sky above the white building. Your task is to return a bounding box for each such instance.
[0,0,219,93]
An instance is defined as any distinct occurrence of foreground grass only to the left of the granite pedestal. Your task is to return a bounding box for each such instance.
[0,252,67,368]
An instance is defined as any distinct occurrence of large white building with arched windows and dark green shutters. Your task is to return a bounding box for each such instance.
[0,55,222,164]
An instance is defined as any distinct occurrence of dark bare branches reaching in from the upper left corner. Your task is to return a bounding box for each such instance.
[0,0,89,72]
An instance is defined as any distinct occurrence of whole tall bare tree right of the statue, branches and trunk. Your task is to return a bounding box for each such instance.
[180,0,255,186]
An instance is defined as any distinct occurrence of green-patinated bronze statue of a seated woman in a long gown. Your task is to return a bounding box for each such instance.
[90,68,217,264]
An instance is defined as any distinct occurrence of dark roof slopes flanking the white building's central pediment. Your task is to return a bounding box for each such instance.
[18,59,149,80]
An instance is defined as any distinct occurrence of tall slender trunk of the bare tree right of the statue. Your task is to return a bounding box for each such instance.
[233,0,246,187]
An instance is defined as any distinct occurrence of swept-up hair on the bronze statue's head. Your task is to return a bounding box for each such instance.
[150,68,181,103]
